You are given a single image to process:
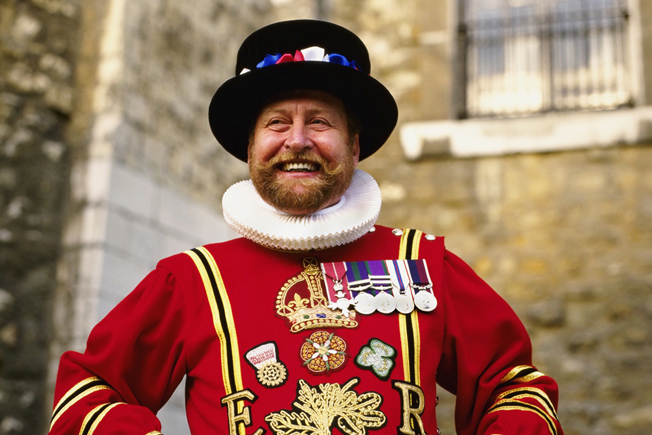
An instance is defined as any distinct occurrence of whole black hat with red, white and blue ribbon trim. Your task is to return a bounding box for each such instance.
[208,20,398,162]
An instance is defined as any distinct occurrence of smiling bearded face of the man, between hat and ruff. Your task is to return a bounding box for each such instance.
[248,91,360,215]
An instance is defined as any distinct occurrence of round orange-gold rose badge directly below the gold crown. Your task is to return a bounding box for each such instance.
[299,331,346,375]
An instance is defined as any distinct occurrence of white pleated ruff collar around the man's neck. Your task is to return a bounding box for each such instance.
[222,169,381,251]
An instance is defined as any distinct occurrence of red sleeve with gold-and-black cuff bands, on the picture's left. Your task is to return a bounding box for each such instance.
[49,268,186,435]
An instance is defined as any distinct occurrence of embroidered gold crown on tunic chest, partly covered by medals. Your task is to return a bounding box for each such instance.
[276,257,358,332]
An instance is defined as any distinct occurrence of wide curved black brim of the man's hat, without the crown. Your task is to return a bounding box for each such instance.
[208,61,398,162]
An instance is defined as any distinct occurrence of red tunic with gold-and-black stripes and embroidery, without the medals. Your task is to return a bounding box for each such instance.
[50,226,562,435]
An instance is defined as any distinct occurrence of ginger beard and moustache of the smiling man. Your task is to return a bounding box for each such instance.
[249,146,355,215]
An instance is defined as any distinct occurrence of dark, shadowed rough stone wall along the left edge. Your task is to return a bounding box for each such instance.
[0,0,79,435]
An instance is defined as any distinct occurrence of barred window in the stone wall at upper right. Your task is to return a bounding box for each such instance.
[459,0,631,117]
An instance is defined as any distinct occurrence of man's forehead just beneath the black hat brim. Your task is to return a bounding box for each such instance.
[258,91,346,117]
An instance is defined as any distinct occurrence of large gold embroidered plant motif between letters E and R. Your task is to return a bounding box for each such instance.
[265,378,387,435]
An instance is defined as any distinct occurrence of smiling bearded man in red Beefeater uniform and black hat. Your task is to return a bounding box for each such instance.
[50,21,561,435]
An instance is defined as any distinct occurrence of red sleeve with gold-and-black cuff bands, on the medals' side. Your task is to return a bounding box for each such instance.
[437,253,563,435]
